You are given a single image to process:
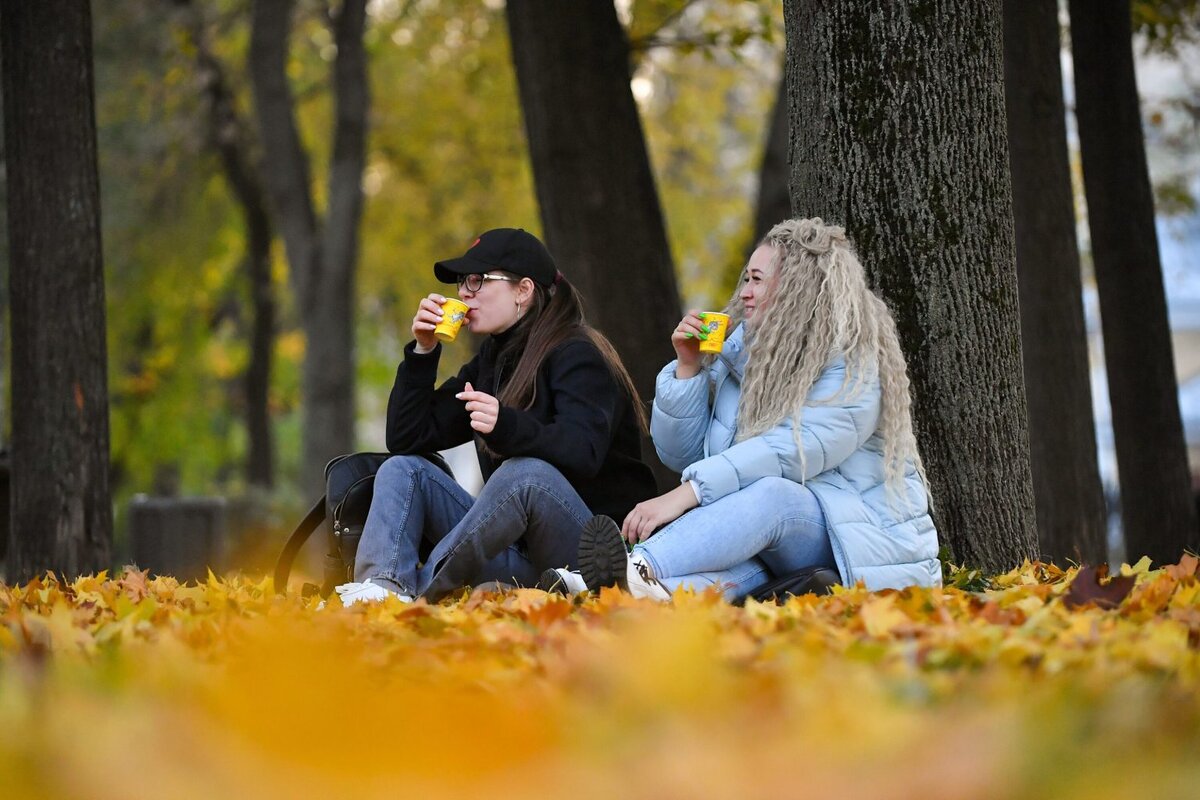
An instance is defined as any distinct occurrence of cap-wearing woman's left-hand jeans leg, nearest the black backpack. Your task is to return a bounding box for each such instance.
[354,456,473,596]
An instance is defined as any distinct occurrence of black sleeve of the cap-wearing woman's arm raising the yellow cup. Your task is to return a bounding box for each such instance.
[386,342,479,455]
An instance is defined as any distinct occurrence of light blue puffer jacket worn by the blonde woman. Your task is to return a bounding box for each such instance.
[650,326,942,590]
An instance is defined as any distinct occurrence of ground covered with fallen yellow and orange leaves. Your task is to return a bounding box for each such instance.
[0,557,1200,799]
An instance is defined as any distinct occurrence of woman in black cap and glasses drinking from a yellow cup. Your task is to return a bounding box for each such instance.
[337,228,655,604]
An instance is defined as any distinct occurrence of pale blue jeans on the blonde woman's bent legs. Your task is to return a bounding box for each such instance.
[634,477,834,600]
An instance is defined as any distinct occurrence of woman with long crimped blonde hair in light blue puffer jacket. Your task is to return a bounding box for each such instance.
[564,218,941,600]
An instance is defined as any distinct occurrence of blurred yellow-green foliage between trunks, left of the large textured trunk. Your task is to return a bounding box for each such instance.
[84,0,782,537]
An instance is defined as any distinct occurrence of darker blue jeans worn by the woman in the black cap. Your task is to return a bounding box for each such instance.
[354,456,592,601]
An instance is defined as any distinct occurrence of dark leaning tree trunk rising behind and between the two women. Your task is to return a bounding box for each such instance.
[506,0,680,489]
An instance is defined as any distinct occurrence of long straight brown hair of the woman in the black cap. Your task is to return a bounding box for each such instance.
[498,276,649,434]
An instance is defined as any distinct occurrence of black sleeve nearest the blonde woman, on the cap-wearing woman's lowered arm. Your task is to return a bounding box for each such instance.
[484,341,623,477]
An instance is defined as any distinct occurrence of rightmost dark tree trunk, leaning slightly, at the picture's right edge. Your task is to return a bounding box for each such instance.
[1069,0,1200,564]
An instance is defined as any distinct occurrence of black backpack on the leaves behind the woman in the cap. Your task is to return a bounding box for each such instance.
[275,453,454,595]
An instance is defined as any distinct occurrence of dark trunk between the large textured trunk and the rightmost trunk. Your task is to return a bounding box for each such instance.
[1004,0,1106,564]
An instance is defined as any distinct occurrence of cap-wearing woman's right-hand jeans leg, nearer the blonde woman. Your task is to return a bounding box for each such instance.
[420,458,592,602]
